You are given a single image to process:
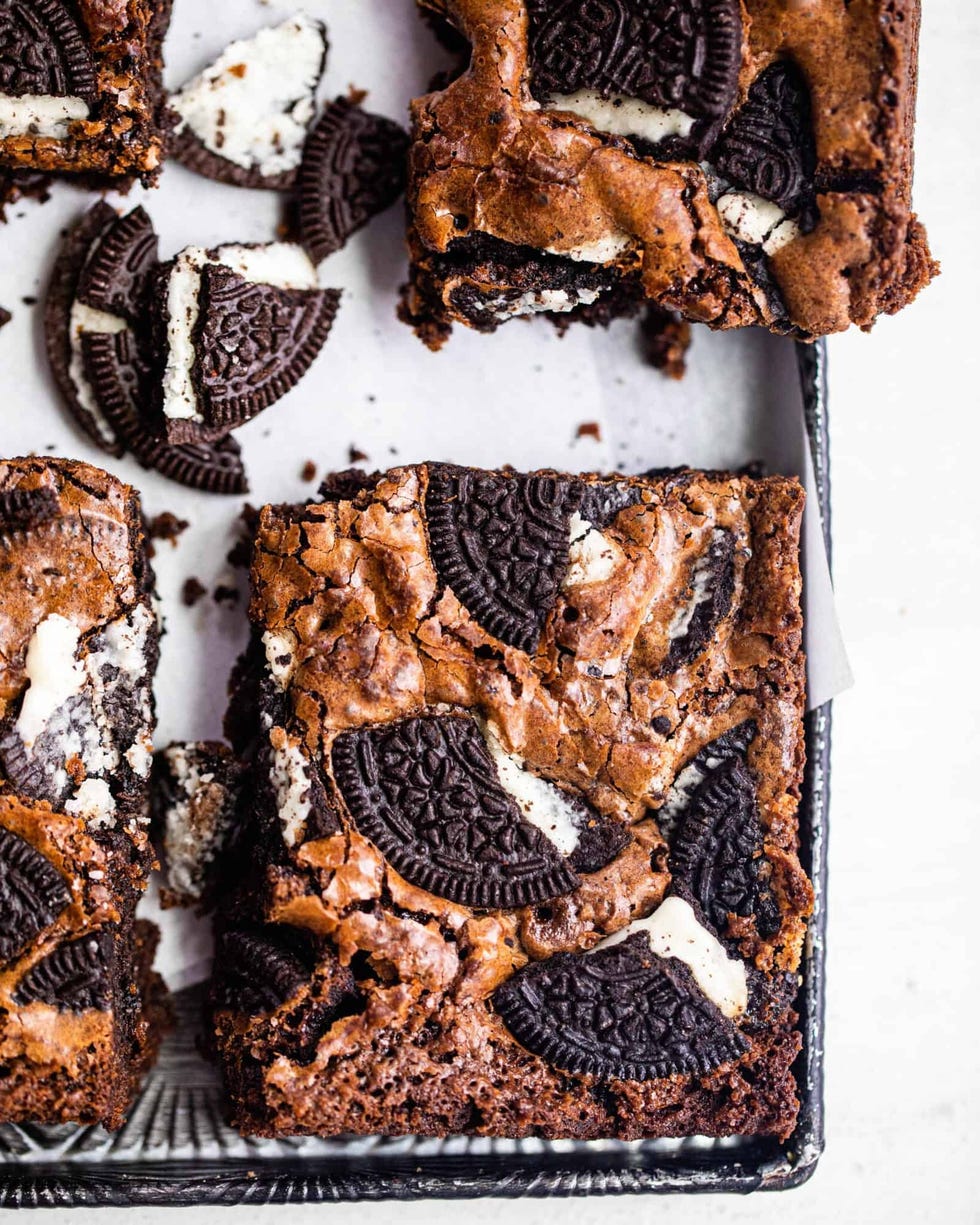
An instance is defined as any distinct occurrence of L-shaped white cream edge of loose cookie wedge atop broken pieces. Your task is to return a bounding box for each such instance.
[163,243,319,421]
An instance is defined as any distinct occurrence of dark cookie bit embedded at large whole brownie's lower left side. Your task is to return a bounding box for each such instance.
[214,926,314,1016]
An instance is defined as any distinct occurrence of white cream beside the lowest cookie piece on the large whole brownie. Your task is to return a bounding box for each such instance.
[592,898,748,1018]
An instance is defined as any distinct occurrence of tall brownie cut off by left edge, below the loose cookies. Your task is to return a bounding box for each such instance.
[0,459,167,1127]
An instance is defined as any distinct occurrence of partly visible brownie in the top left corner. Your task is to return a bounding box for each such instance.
[0,0,172,183]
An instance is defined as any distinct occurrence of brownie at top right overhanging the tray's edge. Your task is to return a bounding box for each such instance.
[405,0,936,345]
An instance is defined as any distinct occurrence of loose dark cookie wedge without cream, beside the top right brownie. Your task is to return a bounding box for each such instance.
[298,98,409,263]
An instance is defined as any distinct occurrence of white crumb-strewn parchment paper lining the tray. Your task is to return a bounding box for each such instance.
[0,0,850,989]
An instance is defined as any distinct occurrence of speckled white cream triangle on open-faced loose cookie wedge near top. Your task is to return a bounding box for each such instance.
[170,13,326,176]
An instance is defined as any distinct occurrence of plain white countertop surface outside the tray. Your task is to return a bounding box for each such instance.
[0,0,980,1225]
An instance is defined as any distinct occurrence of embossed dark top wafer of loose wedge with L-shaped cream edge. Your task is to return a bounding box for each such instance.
[186,265,341,441]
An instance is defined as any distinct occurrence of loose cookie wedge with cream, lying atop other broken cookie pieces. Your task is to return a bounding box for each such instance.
[156,243,341,442]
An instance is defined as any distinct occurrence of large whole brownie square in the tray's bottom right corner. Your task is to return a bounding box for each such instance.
[212,464,811,1139]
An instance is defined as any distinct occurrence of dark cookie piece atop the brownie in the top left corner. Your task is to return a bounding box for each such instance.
[0,0,97,103]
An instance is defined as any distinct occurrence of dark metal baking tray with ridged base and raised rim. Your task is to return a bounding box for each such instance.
[0,342,831,1207]
